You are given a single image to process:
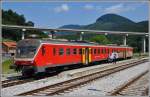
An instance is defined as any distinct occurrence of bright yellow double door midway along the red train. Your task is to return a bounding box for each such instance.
[82,48,92,65]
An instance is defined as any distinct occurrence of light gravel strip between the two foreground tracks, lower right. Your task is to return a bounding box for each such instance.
[60,62,149,96]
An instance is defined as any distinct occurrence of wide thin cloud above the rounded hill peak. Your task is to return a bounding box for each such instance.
[104,4,135,14]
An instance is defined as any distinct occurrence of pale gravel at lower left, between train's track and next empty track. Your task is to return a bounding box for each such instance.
[1,60,148,96]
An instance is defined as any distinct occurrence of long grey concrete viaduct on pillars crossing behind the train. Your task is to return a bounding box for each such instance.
[2,25,149,53]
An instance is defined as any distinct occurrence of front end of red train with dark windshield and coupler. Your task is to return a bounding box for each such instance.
[11,39,40,76]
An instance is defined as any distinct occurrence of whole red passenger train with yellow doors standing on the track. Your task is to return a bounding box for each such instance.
[11,39,133,76]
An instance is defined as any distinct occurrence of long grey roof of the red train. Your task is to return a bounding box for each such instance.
[17,39,131,48]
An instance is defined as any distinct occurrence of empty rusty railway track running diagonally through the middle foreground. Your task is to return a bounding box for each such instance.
[17,59,148,96]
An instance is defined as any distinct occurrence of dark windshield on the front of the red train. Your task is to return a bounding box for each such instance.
[16,46,37,58]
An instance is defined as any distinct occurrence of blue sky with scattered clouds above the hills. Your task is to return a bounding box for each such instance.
[2,1,148,28]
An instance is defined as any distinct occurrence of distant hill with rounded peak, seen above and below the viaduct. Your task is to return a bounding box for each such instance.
[59,14,148,51]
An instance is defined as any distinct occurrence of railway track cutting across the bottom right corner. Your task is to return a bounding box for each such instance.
[110,71,149,96]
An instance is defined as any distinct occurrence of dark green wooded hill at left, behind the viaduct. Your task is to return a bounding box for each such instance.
[2,10,48,41]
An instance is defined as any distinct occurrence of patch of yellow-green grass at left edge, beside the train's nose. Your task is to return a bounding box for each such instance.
[2,59,15,74]
